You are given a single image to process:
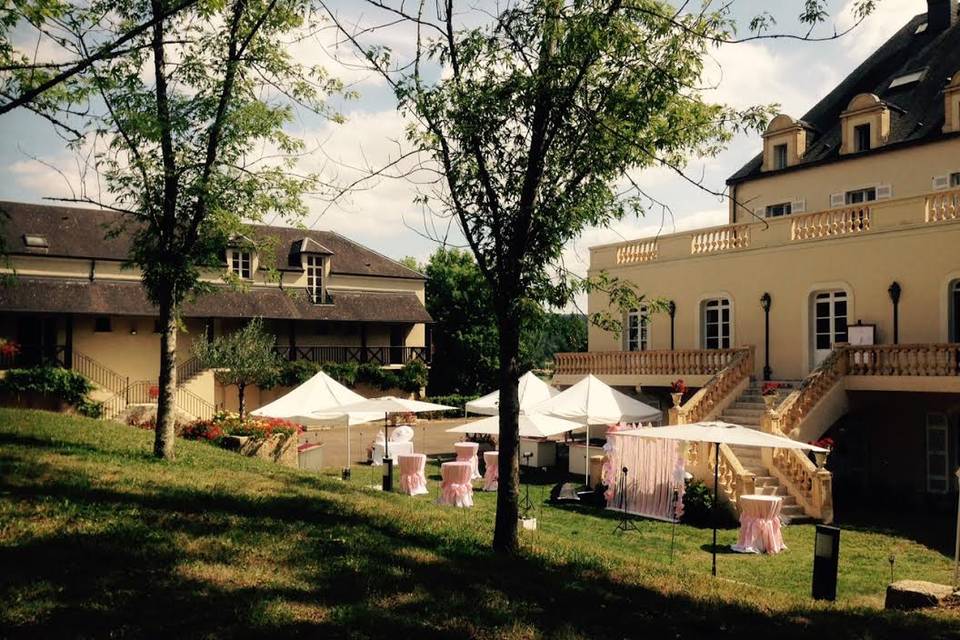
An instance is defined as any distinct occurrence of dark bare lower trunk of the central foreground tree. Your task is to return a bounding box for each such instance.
[493,313,520,554]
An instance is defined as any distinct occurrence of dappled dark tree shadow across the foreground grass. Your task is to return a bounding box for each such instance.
[0,432,960,640]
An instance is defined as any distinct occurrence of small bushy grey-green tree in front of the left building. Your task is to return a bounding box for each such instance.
[194,318,281,420]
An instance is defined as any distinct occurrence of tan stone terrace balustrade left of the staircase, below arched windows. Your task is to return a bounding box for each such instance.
[553,349,747,376]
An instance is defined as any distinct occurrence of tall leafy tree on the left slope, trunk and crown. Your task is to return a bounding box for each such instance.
[0,0,340,459]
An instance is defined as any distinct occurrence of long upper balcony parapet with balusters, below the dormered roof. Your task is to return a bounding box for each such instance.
[590,188,960,270]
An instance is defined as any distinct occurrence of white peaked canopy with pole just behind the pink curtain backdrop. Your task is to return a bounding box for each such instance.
[530,375,661,486]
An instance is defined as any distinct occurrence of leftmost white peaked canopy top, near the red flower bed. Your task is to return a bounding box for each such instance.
[250,371,380,425]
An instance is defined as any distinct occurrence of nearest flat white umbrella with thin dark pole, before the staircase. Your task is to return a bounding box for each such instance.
[617,421,827,575]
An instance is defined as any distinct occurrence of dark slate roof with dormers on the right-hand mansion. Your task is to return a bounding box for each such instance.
[727,14,960,184]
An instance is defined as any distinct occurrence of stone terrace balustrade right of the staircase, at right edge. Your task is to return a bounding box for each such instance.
[842,344,960,376]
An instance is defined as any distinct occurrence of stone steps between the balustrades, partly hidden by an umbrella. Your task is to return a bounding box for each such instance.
[719,380,810,524]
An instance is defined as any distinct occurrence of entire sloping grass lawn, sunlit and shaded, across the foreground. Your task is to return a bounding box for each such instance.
[0,410,960,640]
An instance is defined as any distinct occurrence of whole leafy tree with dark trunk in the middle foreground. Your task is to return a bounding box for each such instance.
[330,0,874,552]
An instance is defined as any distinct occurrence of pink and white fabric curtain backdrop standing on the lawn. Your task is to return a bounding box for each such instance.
[604,429,686,521]
